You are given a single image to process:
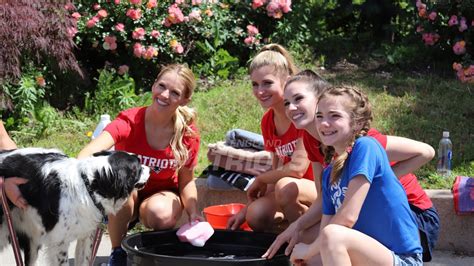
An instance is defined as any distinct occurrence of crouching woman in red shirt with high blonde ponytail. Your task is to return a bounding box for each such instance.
[228,44,316,231]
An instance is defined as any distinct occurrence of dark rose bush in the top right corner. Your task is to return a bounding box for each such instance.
[416,0,474,83]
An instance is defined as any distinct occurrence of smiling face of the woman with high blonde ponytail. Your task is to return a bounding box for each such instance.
[250,66,285,109]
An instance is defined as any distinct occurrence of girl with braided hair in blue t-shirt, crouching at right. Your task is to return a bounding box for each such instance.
[291,86,423,265]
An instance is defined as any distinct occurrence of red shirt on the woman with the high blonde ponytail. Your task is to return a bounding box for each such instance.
[260,109,314,180]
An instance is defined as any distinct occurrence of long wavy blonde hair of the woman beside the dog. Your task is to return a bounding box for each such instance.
[153,64,197,168]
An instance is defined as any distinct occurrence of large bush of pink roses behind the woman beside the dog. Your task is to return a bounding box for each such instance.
[66,0,291,80]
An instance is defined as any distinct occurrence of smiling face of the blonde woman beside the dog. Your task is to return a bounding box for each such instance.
[151,71,189,112]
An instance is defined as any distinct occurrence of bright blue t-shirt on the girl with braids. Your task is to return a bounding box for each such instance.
[323,137,422,254]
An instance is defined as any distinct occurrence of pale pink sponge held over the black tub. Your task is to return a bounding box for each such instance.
[176,222,214,247]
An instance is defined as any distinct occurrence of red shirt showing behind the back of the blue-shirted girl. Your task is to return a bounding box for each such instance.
[367,128,433,210]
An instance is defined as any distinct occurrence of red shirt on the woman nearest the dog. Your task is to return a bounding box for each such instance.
[104,107,200,194]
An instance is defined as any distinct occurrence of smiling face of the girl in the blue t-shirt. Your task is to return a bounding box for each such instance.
[316,95,354,154]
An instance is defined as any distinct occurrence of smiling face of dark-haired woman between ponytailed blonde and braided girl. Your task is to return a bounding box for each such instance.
[283,81,317,131]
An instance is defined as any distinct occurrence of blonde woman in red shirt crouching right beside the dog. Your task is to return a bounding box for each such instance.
[78,65,204,265]
